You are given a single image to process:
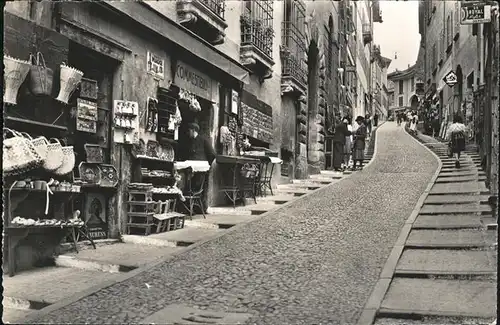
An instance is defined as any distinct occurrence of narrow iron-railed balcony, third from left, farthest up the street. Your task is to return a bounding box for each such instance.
[280,21,307,96]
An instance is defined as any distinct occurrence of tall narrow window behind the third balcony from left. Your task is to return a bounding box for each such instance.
[284,0,306,84]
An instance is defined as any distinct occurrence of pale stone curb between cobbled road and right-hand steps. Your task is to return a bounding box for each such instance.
[357,123,443,325]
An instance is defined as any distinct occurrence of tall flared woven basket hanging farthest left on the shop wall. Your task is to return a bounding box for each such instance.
[3,56,31,105]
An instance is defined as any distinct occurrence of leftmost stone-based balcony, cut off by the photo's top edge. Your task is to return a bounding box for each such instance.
[177,0,227,45]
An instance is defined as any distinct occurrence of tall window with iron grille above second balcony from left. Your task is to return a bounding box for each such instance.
[241,0,274,58]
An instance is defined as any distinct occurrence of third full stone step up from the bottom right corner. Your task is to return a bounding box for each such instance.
[405,229,491,248]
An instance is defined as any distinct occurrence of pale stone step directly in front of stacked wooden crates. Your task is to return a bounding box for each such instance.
[123,227,224,247]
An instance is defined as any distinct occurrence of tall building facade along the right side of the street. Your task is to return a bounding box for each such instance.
[419,1,498,195]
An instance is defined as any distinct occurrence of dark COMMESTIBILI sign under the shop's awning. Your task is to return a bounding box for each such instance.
[175,61,212,100]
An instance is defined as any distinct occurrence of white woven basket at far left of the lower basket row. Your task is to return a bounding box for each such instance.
[2,128,42,176]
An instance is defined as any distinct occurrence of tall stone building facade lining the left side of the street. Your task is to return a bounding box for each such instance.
[4,0,362,248]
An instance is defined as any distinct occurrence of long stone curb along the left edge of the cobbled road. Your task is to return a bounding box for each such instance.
[19,121,385,324]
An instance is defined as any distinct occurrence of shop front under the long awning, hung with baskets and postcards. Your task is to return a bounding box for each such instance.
[4,3,253,268]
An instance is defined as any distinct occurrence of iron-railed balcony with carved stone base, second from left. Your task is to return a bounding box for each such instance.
[240,8,274,83]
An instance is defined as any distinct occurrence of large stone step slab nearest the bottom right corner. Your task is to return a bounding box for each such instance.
[379,278,497,317]
